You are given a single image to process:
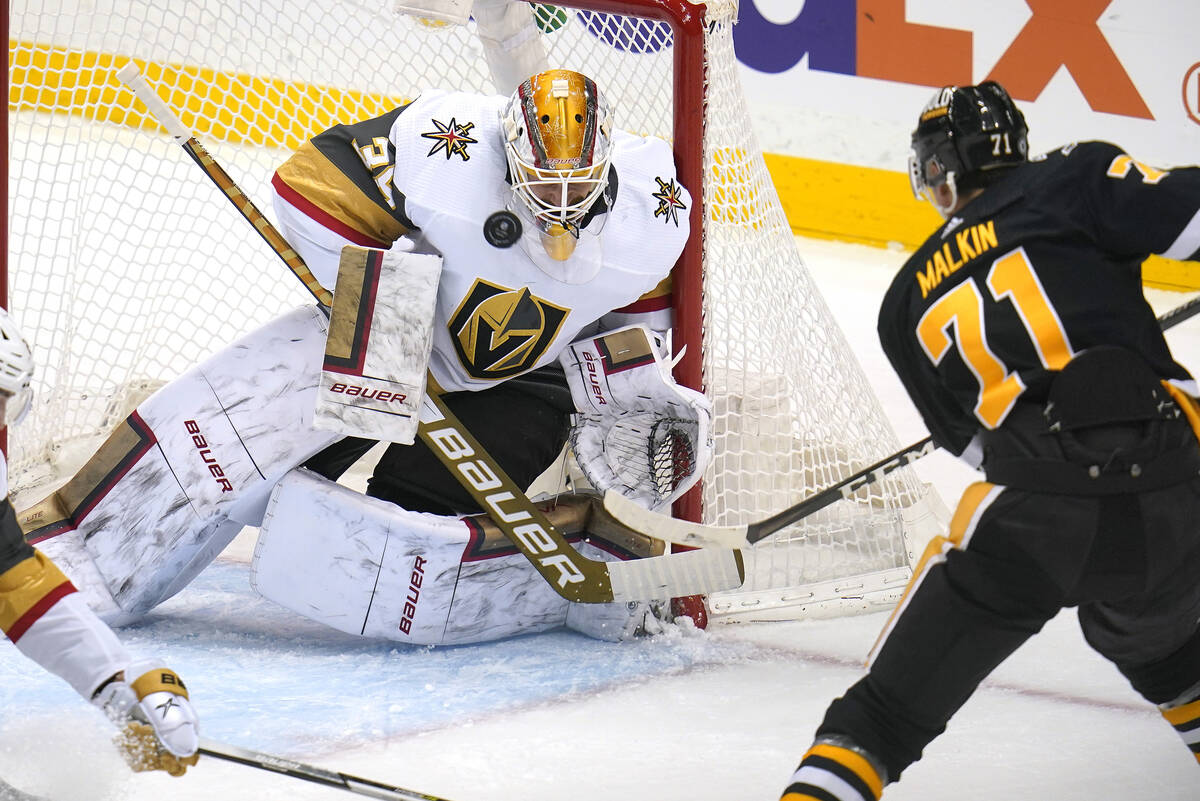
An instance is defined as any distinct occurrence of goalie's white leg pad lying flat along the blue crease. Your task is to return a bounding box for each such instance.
[251,470,643,645]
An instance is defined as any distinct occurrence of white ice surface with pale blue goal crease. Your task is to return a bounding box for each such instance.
[0,240,1200,801]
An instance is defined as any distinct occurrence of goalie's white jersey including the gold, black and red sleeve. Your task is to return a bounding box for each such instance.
[272,91,691,391]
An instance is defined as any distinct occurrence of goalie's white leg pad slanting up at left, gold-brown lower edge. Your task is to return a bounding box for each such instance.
[19,307,336,624]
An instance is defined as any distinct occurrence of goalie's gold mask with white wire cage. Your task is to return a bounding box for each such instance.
[503,70,612,261]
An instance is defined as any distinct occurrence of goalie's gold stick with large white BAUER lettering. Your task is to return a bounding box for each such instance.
[116,61,745,603]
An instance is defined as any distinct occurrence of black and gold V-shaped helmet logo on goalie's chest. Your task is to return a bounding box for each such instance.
[449,278,568,379]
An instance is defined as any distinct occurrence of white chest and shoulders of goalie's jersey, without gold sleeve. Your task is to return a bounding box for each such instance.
[391,91,691,390]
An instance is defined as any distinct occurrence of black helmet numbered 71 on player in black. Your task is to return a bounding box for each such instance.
[908,80,1030,205]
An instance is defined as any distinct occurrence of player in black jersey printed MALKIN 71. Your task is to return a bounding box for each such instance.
[784,82,1200,801]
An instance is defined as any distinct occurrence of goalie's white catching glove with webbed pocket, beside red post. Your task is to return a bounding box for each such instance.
[559,325,713,510]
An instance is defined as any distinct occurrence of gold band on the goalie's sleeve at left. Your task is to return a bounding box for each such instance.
[276,141,407,245]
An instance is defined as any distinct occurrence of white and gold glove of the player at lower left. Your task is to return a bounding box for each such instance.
[91,662,200,776]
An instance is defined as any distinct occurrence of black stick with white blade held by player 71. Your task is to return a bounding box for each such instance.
[604,288,1200,548]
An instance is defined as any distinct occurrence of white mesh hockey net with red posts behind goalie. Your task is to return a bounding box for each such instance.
[7,0,940,618]
